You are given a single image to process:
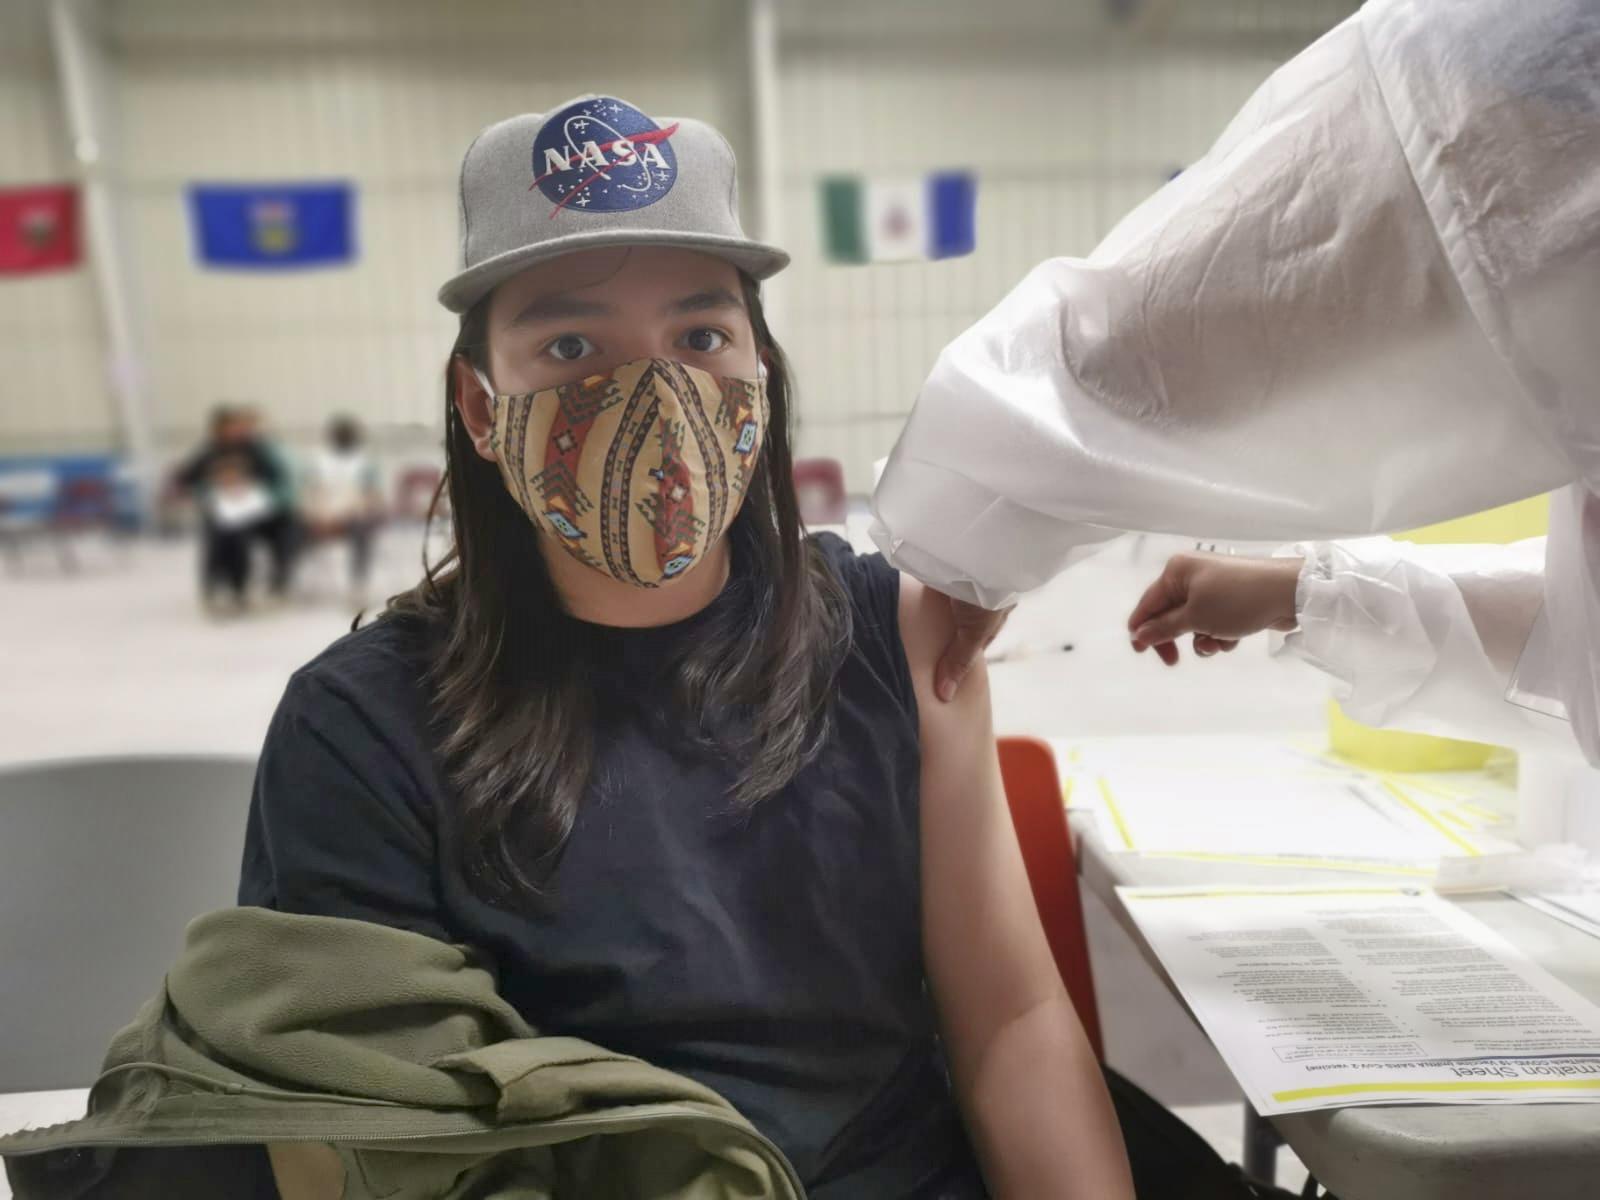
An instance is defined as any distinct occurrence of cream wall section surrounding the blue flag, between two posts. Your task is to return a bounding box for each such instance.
[114,0,742,460]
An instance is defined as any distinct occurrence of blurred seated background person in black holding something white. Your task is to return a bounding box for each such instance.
[173,405,294,608]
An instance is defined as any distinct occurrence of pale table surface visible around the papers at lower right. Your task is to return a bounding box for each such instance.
[1074,816,1600,1200]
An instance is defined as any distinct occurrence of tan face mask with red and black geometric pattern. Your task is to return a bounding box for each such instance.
[478,358,768,587]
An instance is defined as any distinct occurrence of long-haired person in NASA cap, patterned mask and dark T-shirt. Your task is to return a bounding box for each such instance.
[240,98,1133,1200]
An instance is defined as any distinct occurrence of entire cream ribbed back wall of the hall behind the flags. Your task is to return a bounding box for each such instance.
[0,0,1354,491]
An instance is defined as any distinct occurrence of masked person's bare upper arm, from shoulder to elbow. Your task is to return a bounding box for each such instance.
[899,576,1062,1078]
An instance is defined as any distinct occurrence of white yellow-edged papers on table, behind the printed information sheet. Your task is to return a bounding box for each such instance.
[1075,768,1504,870]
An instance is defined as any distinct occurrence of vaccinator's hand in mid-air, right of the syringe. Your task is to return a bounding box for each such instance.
[1128,554,1304,666]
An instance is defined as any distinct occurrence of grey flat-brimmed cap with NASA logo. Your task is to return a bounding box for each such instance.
[438,96,789,312]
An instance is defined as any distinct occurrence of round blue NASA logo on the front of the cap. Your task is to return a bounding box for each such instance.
[530,96,678,216]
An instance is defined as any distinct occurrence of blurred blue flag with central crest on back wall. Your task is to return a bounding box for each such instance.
[189,184,355,269]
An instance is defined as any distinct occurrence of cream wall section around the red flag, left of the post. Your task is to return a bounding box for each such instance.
[0,0,115,453]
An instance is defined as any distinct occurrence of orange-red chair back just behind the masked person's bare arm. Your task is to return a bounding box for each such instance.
[998,738,1106,1058]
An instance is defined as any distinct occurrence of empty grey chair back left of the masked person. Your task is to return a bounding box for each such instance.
[0,757,254,1091]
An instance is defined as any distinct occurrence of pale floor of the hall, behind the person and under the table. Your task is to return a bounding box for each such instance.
[0,515,1326,1197]
